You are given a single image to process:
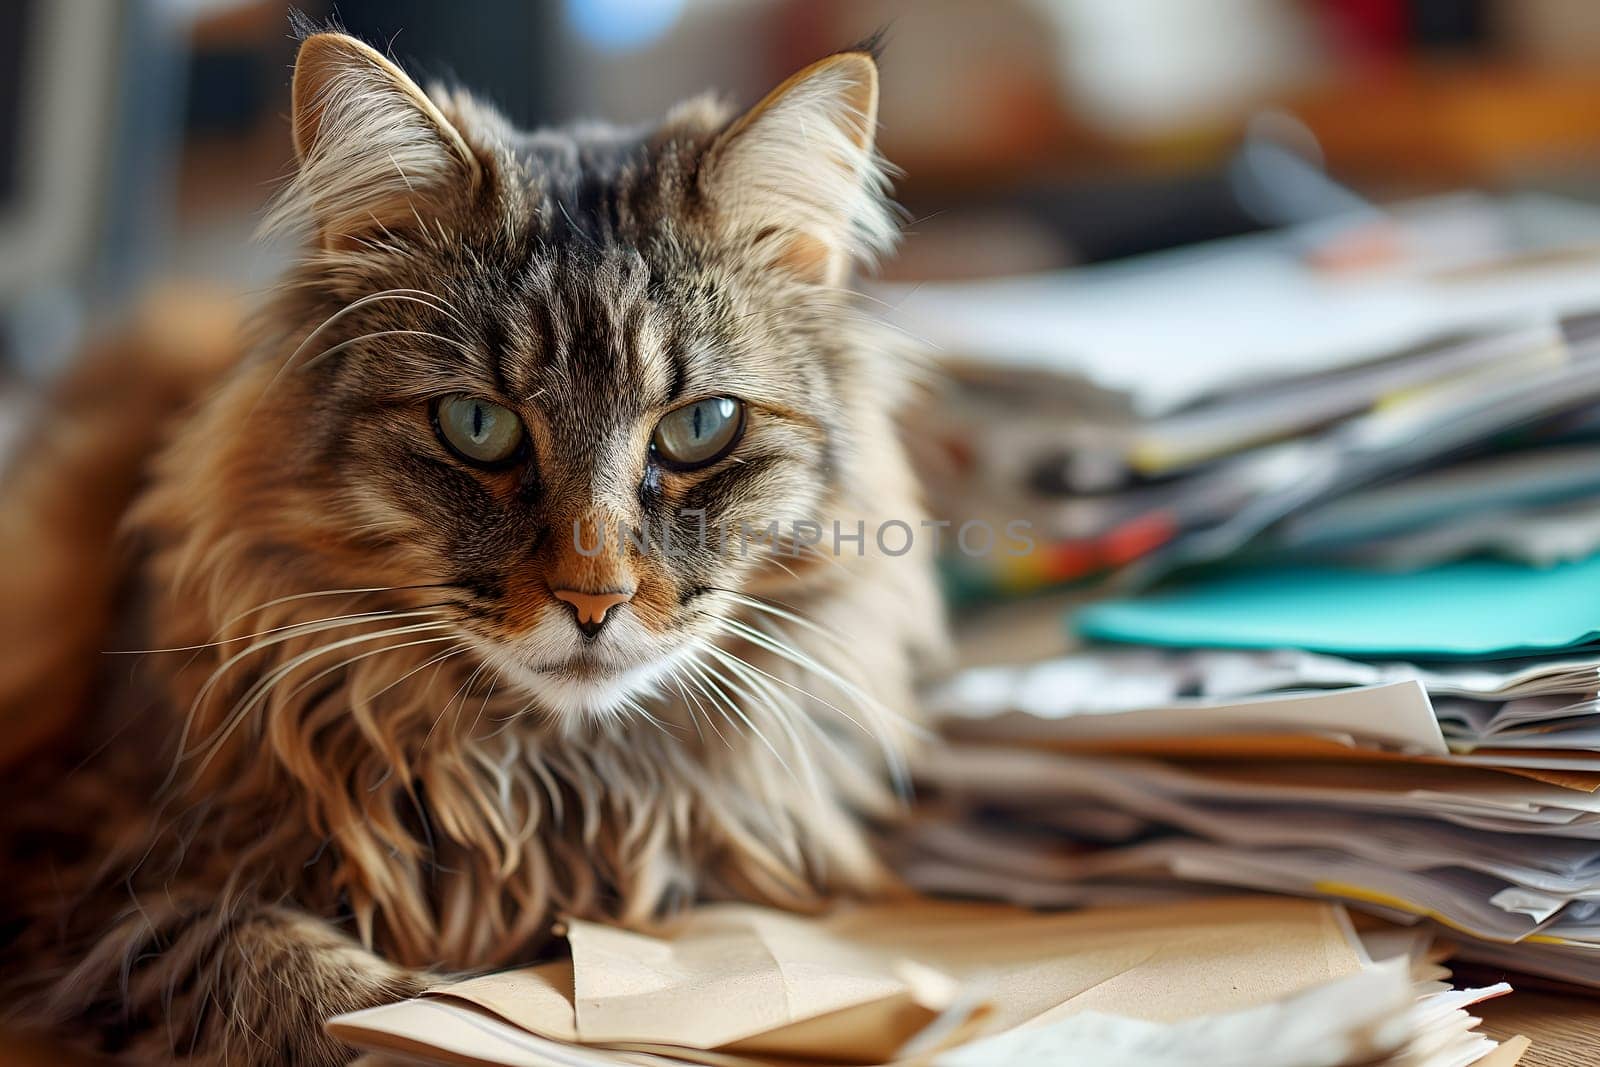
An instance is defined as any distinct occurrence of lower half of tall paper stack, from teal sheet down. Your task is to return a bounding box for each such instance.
[909,560,1600,985]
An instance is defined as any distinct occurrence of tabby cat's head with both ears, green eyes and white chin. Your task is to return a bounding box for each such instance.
[208,34,899,726]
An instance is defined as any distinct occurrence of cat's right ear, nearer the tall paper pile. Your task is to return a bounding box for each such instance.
[702,51,898,285]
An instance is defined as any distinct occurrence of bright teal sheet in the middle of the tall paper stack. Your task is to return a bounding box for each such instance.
[1077,557,1600,659]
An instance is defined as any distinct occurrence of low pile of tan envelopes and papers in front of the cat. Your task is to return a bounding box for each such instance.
[330,897,1525,1067]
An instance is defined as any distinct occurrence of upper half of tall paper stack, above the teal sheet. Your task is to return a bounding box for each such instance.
[886,191,1600,595]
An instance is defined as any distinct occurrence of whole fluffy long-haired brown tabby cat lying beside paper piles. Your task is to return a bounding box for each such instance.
[0,34,939,1064]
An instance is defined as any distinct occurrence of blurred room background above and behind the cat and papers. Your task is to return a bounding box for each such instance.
[15,0,1600,371]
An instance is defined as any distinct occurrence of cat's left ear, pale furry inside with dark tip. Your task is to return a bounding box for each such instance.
[290,34,482,246]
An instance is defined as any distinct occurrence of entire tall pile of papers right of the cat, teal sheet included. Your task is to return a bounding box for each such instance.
[901,191,1600,1004]
